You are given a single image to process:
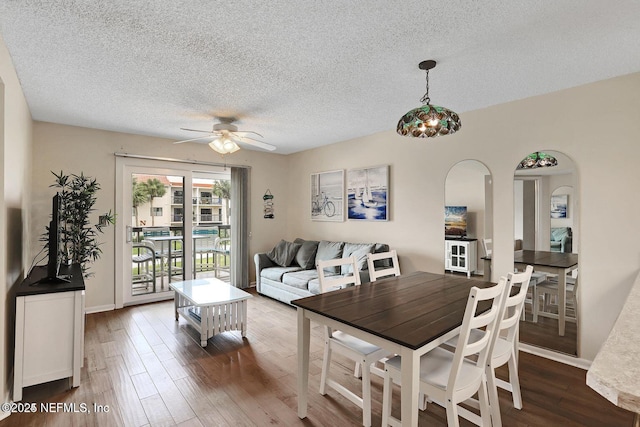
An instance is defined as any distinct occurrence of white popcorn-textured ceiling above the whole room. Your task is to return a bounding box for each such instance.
[0,0,640,153]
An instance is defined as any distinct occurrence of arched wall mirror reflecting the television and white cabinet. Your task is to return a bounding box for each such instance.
[444,160,493,277]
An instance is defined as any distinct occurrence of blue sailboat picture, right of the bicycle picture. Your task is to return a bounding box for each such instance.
[347,165,389,221]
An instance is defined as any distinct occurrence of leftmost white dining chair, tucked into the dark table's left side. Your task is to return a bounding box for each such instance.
[316,256,387,427]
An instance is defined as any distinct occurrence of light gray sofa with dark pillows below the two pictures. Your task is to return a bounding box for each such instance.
[253,239,389,304]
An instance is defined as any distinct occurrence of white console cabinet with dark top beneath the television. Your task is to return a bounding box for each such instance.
[13,265,84,402]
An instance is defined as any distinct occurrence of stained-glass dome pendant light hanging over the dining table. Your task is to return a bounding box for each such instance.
[397,60,462,138]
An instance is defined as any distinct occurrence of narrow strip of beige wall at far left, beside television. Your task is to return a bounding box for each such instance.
[0,37,32,410]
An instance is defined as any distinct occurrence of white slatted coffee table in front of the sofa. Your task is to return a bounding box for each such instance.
[169,278,251,347]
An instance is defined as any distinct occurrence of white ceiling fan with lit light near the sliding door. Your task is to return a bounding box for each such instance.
[174,118,276,154]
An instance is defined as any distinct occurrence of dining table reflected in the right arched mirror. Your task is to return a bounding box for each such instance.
[513,250,578,336]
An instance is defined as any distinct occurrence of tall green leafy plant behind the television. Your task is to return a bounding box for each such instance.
[51,171,115,277]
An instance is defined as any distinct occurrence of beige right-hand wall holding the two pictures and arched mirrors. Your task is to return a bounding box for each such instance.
[287,73,640,360]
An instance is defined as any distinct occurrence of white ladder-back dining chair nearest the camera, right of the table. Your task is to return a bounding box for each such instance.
[382,277,507,426]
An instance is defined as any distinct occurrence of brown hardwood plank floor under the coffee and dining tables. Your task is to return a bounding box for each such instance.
[0,291,633,427]
